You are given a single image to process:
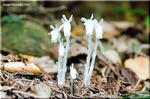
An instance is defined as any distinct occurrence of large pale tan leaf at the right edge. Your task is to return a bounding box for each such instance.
[124,56,150,80]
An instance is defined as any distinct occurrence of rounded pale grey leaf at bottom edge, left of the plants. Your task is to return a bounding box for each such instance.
[35,83,51,98]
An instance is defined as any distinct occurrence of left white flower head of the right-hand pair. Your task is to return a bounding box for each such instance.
[81,14,94,35]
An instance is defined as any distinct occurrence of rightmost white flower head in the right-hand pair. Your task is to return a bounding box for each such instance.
[94,19,104,39]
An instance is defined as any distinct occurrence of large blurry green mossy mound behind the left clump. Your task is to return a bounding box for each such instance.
[2,21,50,56]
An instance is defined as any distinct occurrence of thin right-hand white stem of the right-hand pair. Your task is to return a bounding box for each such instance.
[89,38,98,79]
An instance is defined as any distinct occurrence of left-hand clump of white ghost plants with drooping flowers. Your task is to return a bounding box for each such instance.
[48,15,72,85]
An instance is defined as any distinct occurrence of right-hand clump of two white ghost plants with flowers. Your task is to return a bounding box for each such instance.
[81,14,103,86]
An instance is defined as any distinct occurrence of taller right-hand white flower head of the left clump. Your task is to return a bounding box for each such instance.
[61,15,72,37]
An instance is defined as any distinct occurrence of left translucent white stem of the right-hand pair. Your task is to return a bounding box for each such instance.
[83,35,92,86]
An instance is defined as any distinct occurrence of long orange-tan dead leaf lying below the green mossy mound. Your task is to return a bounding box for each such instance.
[4,62,42,73]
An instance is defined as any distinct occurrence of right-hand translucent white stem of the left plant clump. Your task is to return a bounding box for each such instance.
[62,36,69,83]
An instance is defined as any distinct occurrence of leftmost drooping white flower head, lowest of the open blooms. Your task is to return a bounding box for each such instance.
[48,25,59,42]
